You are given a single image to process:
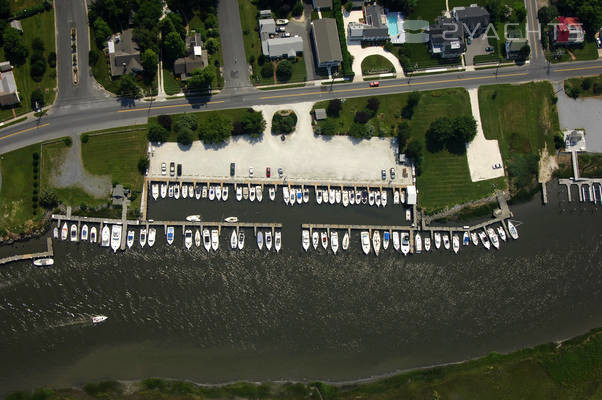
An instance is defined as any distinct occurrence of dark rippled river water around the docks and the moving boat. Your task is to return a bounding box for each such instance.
[0,187,602,393]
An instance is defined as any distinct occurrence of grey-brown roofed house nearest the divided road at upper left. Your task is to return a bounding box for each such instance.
[107,29,143,76]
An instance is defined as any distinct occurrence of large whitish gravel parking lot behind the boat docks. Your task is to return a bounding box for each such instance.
[150,103,412,185]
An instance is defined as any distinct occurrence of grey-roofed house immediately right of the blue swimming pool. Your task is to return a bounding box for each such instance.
[429,17,466,58]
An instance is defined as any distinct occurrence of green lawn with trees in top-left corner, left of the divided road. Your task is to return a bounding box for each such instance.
[0,11,56,121]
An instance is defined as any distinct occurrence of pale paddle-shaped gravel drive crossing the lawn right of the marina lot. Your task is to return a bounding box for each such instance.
[466,88,504,182]
